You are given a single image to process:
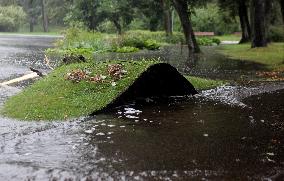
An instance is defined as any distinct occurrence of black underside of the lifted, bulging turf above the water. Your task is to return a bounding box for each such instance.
[102,63,198,111]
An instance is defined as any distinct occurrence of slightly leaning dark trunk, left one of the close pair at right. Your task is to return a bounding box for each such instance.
[238,0,251,43]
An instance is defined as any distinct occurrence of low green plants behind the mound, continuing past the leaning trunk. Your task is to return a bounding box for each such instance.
[46,28,220,59]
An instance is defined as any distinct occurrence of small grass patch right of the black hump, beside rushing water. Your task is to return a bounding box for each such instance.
[185,76,227,90]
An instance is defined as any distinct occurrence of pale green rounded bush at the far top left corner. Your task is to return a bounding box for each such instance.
[0,6,26,32]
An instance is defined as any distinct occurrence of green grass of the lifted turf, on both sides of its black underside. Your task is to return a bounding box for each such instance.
[1,61,226,120]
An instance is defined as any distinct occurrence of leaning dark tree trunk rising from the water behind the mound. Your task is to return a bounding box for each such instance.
[173,0,200,53]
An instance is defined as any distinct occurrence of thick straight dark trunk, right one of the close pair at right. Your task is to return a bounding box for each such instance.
[251,0,267,48]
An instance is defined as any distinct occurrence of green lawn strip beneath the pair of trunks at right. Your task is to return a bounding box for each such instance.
[218,43,284,70]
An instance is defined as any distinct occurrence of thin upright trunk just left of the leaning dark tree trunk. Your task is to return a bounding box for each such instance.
[161,0,173,36]
